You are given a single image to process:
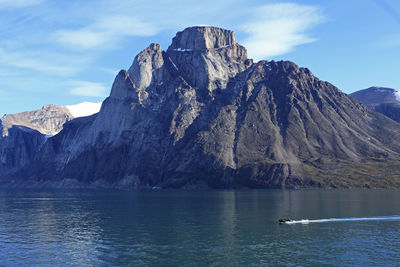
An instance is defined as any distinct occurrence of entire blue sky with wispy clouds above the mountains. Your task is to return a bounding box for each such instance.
[0,0,400,116]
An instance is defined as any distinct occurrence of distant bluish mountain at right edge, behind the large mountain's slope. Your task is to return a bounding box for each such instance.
[350,87,400,122]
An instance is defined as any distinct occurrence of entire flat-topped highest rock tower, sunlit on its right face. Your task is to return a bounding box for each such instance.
[167,26,253,98]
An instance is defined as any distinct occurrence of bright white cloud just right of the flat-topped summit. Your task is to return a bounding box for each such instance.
[241,3,324,60]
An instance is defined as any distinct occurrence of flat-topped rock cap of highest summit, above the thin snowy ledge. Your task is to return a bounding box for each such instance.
[169,26,236,51]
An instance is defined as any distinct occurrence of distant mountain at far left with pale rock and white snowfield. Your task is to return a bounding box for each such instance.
[0,102,101,174]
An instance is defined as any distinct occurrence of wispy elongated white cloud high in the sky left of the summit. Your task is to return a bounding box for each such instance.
[53,16,158,50]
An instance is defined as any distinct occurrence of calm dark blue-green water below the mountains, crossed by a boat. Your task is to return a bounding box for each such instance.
[0,190,400,266]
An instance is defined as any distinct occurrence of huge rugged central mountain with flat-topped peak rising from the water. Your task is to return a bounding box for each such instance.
[2,26,400,191]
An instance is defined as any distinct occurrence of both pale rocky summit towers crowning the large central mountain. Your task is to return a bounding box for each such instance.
[111,26,253,104]
